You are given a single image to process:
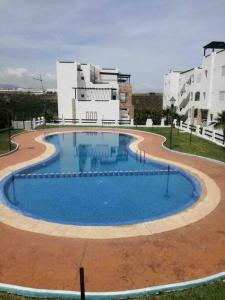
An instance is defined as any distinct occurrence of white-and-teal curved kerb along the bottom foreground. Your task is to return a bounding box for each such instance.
[0,272,225,300]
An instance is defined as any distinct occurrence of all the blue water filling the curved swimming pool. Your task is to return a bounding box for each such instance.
[4,133,200,226]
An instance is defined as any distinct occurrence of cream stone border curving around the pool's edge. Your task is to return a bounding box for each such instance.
[0,129,221,239]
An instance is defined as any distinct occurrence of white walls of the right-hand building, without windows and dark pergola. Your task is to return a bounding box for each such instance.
[163,50,225,124]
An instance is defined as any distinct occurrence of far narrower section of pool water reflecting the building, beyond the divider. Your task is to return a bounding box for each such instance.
[26,132,157,173]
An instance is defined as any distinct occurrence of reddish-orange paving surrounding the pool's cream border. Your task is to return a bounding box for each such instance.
[0,128,225,291]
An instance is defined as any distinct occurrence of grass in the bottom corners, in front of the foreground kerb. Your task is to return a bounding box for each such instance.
[0,281,225,300]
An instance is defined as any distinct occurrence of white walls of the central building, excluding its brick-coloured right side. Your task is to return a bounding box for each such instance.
[57,62,120,120]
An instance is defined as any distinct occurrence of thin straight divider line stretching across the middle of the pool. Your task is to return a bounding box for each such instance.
[14,169,179,178]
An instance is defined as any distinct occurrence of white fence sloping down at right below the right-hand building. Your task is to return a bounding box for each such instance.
[176,121,225,147]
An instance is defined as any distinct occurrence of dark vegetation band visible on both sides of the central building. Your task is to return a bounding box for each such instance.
[0,92,183,129]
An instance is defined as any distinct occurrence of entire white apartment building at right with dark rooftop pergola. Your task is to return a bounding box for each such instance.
[163,42,225,125]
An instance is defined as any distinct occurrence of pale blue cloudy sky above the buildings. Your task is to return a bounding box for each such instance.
[0,0,225,92]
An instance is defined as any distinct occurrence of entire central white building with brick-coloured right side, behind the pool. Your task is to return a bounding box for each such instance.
[57,61,134,121]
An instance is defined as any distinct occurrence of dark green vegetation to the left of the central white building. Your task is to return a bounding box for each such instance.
[0,92,57,128]
